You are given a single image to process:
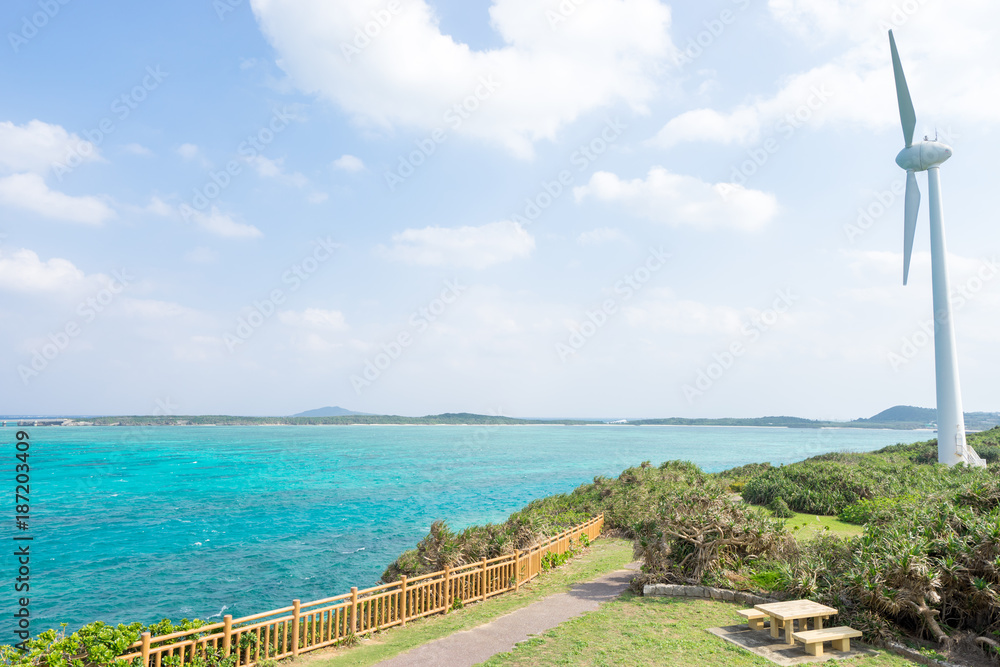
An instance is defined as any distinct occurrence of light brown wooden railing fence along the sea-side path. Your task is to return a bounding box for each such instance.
[115,514,604,667]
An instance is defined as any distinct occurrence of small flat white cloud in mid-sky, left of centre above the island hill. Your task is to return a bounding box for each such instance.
[379,221,535,269]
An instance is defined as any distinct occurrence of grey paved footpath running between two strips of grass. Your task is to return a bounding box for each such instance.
[378,563,638,667]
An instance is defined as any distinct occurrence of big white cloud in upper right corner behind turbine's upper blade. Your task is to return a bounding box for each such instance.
[654,0,1000,147]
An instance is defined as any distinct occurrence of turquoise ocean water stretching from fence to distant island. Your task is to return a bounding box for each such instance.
[9,426,933,643]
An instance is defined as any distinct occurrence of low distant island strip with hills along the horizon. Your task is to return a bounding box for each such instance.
[7,405,1000,431]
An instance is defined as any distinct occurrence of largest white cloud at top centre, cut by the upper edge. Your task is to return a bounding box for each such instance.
[251,0,674,157]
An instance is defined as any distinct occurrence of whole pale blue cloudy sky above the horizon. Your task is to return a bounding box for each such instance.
[0,0,1000,419]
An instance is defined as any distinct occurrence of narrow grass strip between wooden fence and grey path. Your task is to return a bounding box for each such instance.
[292,537,632,667]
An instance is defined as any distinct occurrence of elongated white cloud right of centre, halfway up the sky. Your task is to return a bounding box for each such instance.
[573,167,778,230]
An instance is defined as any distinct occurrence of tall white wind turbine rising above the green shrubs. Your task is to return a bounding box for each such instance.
[889,30,985,466]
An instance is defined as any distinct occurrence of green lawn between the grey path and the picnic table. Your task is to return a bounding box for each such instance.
[483,593,913,667]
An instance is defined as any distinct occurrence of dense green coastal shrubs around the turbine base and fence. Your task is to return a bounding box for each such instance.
[0,428,1000,667]
